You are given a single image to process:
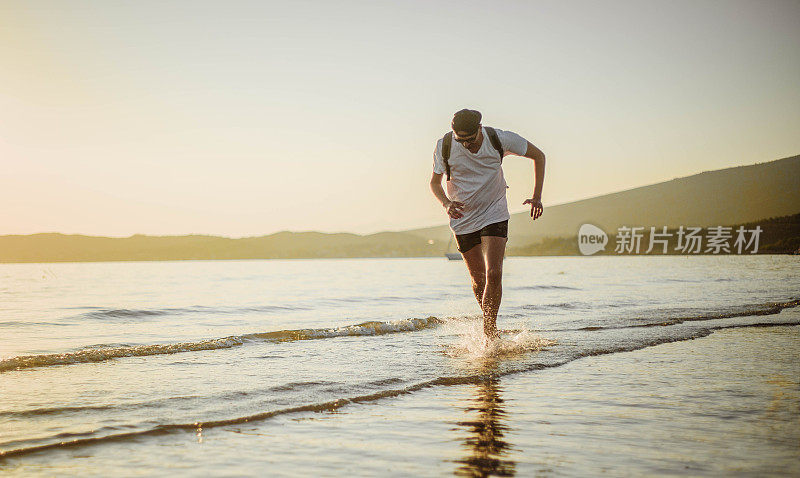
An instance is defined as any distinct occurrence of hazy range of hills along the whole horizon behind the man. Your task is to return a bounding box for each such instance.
[0,156,800,262]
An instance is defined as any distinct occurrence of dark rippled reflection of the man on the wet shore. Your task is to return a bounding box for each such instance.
[453,361,516,476]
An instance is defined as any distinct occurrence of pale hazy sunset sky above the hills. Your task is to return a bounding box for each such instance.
[0,0,800,237]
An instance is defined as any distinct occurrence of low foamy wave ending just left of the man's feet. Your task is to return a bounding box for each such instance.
[0,317,442,373]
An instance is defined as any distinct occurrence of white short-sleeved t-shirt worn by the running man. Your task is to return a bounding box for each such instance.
[433,128,528,234]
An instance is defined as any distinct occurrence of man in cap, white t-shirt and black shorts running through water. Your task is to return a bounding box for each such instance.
[430,109,545,338]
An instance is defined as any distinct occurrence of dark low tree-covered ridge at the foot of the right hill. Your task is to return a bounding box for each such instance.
[508,214,800,256]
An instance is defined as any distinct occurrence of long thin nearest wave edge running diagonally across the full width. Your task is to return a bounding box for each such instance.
[0,321,800,460]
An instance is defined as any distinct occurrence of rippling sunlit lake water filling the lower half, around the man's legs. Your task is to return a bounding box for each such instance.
[0,255,800,476]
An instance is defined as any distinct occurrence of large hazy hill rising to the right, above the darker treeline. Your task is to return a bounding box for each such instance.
[406,156,800,245]
